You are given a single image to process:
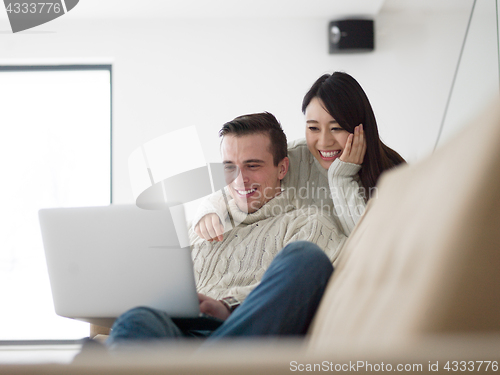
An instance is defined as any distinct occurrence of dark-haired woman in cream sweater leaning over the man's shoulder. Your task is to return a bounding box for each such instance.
[193,72,404,241]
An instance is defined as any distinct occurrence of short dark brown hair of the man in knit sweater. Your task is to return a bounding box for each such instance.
[219,112,288,166]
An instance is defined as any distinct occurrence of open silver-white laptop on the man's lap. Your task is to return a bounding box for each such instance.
[39,205,221,329]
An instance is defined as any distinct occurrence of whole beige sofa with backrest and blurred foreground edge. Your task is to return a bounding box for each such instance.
[0,103,500,374]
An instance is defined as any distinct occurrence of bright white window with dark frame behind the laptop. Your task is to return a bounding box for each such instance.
[0,65,111,340]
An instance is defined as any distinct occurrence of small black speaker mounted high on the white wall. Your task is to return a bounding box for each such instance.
[328,19,375,54]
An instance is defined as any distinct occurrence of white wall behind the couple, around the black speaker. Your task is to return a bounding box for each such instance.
[0,0,488,203]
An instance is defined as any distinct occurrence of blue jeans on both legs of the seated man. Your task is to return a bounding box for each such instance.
[107,241,333,346]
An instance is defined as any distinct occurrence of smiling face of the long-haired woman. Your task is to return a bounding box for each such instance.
[305,97,350,169]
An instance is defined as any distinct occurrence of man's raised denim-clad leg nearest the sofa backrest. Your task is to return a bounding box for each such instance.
[208,241,333,342]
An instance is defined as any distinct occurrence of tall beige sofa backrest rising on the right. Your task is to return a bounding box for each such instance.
[309,103,500,349]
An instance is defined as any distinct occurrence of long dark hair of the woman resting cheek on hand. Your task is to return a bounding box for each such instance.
[302,72,405,191]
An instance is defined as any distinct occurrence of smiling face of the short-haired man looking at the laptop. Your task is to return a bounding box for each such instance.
[221,133,288,213]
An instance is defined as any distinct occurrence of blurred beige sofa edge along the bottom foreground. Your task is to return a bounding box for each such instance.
[0,334,500,375]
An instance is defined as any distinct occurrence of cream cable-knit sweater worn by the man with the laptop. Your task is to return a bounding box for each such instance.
[190,192,346,301]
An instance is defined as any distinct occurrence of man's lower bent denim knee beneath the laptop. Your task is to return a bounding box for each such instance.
[106,307,184,346]
